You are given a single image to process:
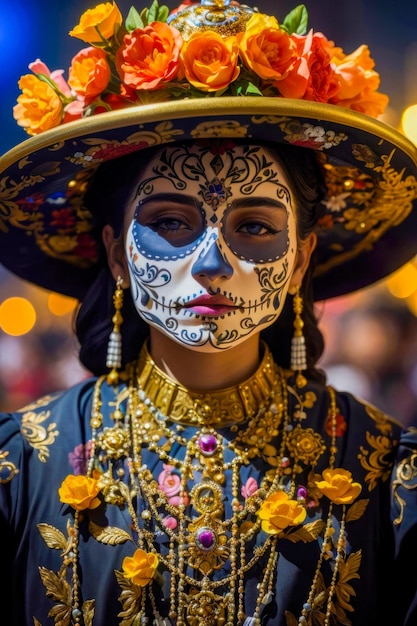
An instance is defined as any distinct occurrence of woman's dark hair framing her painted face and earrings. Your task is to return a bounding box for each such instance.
[75,140,325,382]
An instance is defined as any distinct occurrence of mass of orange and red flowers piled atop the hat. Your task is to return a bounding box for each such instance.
[13,0,388,135]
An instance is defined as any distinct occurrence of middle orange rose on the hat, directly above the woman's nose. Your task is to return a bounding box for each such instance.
[181,31,240,92]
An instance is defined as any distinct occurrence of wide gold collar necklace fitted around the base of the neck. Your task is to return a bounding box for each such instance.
[137,343,280,428]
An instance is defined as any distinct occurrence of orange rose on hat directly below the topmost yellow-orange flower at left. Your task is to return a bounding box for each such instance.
[68,48,111,104]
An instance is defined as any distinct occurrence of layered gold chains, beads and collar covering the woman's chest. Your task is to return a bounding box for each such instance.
[83,345,334,626]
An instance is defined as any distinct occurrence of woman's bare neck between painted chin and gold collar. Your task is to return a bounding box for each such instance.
[149,328,262,391]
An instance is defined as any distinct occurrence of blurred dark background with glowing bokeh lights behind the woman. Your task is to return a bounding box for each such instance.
[0,0,417,425]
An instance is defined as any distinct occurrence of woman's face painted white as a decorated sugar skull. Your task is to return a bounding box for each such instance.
[126,141,297,352]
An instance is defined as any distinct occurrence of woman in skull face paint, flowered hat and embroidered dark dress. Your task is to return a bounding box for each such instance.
[0,4,417,626]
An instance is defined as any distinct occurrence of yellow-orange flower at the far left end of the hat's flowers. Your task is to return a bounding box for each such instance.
[13,74,63,135]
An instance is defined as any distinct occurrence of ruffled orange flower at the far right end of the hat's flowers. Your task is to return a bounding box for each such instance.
[329,45,389,117]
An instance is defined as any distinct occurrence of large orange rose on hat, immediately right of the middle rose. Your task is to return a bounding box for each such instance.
[238,13,297,81]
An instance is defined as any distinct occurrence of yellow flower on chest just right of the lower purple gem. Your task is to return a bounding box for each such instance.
[258,491,307,535]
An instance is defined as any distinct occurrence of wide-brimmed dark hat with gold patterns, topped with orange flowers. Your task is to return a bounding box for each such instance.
[0,3,417,300]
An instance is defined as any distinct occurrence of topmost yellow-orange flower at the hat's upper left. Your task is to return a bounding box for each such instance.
[69,2,123,45]
